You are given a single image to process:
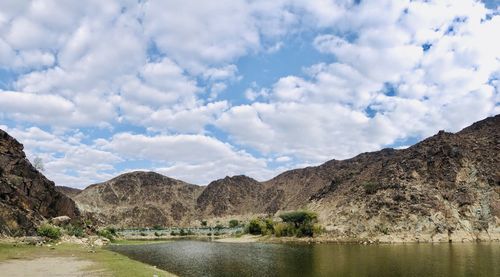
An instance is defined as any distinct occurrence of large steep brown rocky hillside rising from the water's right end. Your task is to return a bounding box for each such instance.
[305,113,500,241]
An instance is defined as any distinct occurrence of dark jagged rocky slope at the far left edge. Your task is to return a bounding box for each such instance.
[0,130,79,236]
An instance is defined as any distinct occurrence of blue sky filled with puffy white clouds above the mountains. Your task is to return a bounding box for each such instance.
[0,0,500,188]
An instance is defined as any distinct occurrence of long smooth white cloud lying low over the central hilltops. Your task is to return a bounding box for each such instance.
[99,133,274,184]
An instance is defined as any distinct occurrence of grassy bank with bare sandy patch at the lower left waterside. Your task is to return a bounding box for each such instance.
[0,238,176,277]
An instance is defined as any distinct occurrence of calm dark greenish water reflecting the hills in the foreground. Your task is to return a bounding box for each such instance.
[110,238,500,277]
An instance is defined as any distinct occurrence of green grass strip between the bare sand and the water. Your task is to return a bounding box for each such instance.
[0,240,175,277]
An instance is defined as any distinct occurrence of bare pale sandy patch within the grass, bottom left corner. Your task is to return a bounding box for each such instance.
[0,257,99,277]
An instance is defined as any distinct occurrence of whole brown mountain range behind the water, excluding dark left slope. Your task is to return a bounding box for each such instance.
[56,115,500,241]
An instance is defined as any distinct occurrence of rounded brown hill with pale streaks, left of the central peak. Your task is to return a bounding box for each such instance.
[74,171,203,227]
